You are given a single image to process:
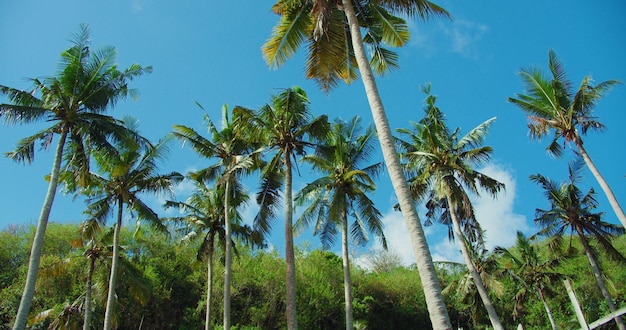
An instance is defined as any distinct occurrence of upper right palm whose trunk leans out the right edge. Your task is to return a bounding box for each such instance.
[509,50,626,228]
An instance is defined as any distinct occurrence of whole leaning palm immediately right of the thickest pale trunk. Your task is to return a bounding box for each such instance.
[398,86,504,329]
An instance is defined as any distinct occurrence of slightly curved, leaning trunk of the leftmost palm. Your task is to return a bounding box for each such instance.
[13,126,68,330]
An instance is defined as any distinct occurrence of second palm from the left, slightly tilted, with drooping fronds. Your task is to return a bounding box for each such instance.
[79,118,183,330]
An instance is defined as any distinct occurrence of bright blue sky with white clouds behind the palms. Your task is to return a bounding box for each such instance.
[0,0,626,262]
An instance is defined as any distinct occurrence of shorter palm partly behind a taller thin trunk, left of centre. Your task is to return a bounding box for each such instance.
[164,177,260,330]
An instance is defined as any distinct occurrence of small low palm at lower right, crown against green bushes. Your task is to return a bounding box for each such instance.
[494,231,563,330]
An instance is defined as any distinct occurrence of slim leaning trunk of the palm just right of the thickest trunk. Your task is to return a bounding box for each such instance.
[446,195,504,330]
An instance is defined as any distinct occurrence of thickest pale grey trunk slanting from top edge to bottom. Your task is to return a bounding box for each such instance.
[342,0,452,329]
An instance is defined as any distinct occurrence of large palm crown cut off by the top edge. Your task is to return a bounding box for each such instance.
[263,0,449,90]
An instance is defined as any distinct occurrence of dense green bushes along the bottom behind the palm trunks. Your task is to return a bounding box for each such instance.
[0,223,626,329]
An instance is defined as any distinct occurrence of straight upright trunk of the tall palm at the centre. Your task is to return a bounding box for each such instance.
[283,150,298,330]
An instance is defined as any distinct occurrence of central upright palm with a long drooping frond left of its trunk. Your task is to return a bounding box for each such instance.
[233,86,329,329]
